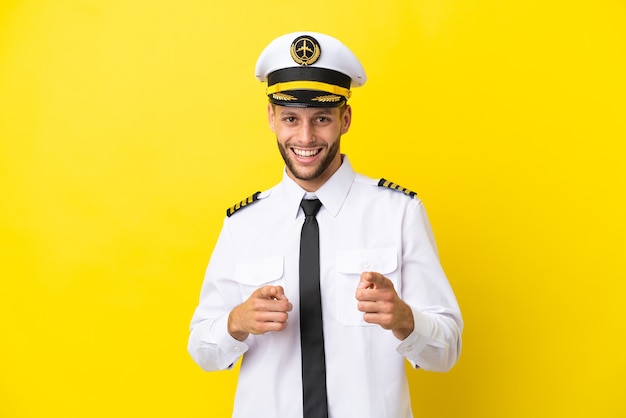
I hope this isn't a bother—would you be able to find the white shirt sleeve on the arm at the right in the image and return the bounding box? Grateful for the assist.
[397,199,463,371]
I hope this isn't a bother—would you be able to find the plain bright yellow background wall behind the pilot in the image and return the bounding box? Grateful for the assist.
[0,0,626,418]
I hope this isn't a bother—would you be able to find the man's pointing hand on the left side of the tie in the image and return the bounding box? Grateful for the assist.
[228,286,293,341]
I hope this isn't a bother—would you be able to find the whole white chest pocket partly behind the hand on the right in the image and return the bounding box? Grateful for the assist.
[335,247,400,326]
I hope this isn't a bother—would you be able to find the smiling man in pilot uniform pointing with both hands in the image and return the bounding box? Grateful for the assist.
[189,32,463,418]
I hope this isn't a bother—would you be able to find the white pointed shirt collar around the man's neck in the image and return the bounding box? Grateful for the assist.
[282,154,356,219]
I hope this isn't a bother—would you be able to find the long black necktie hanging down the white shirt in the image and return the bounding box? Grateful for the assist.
[300,199,328,418]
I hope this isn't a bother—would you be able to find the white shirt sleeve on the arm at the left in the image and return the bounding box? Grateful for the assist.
[187,220,249,371]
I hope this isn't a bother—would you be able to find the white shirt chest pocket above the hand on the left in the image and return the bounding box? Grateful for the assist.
[234,256,285,301]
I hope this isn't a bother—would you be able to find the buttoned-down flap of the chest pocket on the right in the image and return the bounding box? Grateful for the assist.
[337,248,398,274]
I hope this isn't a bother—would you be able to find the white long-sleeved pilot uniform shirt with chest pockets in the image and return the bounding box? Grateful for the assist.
[189,156,463,418]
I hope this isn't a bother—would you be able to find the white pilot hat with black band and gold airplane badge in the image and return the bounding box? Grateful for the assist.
[255,32,367,107]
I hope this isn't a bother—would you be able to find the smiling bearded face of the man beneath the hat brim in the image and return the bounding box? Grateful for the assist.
[268,104,352,191]
